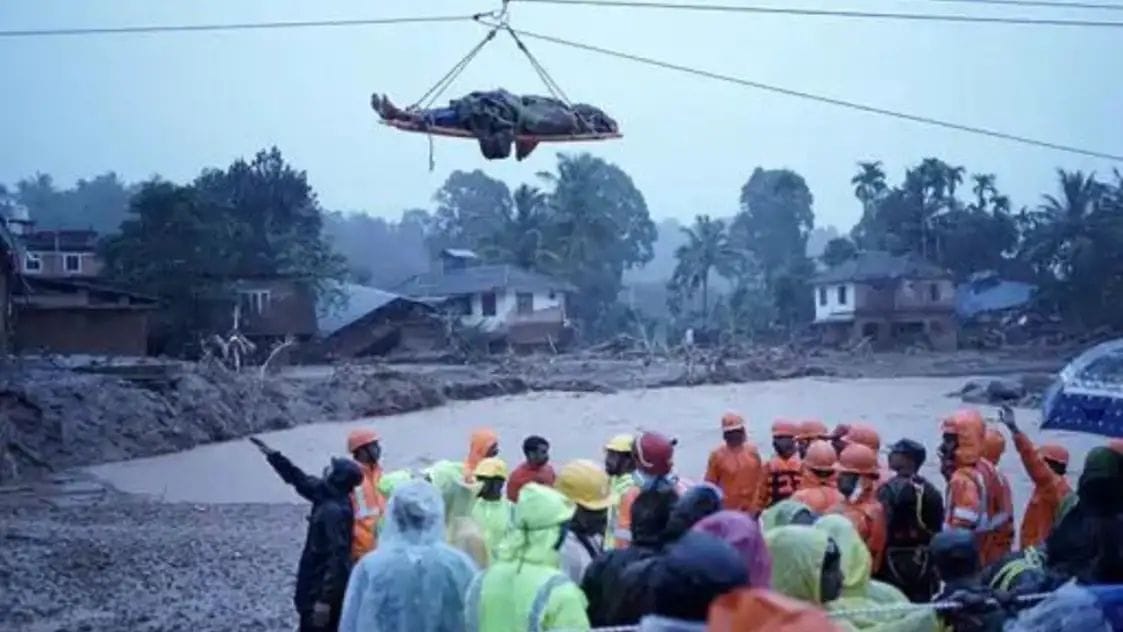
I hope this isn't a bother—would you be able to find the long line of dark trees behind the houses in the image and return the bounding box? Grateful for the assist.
[0,148,1123,350]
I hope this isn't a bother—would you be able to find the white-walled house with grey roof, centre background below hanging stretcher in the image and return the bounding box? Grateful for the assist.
[395,249,575,348]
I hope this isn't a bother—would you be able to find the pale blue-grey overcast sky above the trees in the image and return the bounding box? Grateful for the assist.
[0,0,1123,228]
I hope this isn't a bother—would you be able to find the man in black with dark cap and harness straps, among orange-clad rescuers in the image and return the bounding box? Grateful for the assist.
[877,439,944,603]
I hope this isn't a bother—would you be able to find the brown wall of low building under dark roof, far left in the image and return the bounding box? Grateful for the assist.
[12,306,149,356]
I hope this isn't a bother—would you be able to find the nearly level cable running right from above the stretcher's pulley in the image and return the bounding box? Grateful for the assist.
[512,0,1123,28]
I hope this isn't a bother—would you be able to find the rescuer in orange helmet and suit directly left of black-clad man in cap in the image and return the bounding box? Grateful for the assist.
[833,443,886,570]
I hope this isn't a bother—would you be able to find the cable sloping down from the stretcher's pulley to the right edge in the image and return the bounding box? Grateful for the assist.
[478,20,1123,163]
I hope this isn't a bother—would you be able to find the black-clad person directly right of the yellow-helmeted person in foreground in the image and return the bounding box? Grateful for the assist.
[581,487,678,628]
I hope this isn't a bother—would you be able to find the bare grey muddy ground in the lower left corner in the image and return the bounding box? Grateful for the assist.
[0,484,307,632]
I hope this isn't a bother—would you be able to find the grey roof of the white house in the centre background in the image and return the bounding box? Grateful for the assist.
[394,265,575,297]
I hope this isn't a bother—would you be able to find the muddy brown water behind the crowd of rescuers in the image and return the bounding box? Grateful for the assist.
[90,377,1103,513]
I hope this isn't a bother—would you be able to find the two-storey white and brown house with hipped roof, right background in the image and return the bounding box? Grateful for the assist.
[813,250,959,350]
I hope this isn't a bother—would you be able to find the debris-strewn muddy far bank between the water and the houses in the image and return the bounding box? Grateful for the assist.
[0,348,1069,483]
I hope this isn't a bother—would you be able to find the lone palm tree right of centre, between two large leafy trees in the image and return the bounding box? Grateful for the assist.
[672,216,745,321]
